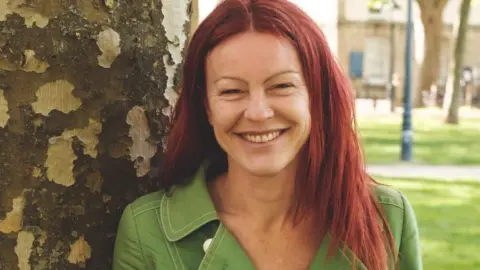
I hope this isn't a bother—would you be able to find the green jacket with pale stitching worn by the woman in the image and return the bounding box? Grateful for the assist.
[113,163,422,270]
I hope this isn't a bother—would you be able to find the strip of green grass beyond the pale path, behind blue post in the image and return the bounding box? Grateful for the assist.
[358,114,480,165]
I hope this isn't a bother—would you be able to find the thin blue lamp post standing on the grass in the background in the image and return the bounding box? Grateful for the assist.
[401,0,413,161]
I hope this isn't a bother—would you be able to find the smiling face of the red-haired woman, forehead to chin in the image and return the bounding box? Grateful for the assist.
[206,31,310,176]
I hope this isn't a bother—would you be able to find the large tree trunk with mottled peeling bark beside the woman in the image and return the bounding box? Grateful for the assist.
[0,0,190,270]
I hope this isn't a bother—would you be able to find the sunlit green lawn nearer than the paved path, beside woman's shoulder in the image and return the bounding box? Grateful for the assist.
[379,178,480,270]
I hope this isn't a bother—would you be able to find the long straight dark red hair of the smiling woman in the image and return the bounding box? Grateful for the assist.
[161,0,396,270]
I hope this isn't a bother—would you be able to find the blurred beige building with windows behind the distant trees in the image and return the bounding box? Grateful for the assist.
[337,0,480,103]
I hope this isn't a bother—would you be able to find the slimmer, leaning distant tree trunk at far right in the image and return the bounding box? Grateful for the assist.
[443,0,472,124]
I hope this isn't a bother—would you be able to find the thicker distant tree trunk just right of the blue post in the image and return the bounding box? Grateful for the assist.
[414,0,448,107]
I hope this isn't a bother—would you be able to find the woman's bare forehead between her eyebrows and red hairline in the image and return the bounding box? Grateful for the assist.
[206,31,300,76]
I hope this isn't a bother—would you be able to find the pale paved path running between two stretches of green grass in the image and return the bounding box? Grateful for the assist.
[367,164,480,181]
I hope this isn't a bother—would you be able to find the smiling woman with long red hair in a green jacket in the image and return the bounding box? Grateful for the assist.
[113,0,422,270]
